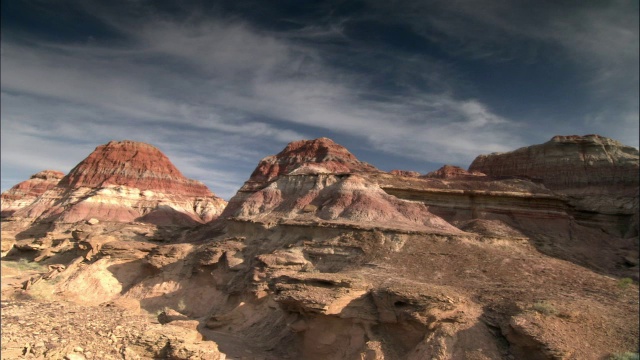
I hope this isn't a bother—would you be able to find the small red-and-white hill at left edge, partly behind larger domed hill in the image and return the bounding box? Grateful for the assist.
[0,170,64,218]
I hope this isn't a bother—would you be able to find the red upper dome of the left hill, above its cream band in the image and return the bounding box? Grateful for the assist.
[60,140,213,196]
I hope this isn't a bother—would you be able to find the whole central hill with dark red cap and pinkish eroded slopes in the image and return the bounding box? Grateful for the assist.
[221,138,459,233]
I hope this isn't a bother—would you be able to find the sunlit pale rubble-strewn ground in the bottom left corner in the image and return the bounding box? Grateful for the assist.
[0,261,225,360]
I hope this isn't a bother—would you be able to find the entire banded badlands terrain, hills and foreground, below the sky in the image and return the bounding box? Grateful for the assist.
[2,135,639,360]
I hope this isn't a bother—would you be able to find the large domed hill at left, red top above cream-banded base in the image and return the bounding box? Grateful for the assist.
[2,141,226,225]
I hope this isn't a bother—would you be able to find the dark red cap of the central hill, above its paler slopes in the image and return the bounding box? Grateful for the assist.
[249,137,379,182]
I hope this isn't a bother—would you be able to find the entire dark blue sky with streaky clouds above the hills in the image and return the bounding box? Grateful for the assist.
[0,0,640,199]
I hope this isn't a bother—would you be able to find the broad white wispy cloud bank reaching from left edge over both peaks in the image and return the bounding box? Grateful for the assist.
[2,4,517,197]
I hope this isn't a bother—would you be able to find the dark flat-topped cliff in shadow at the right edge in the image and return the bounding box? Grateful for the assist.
[469,135,639,237]
